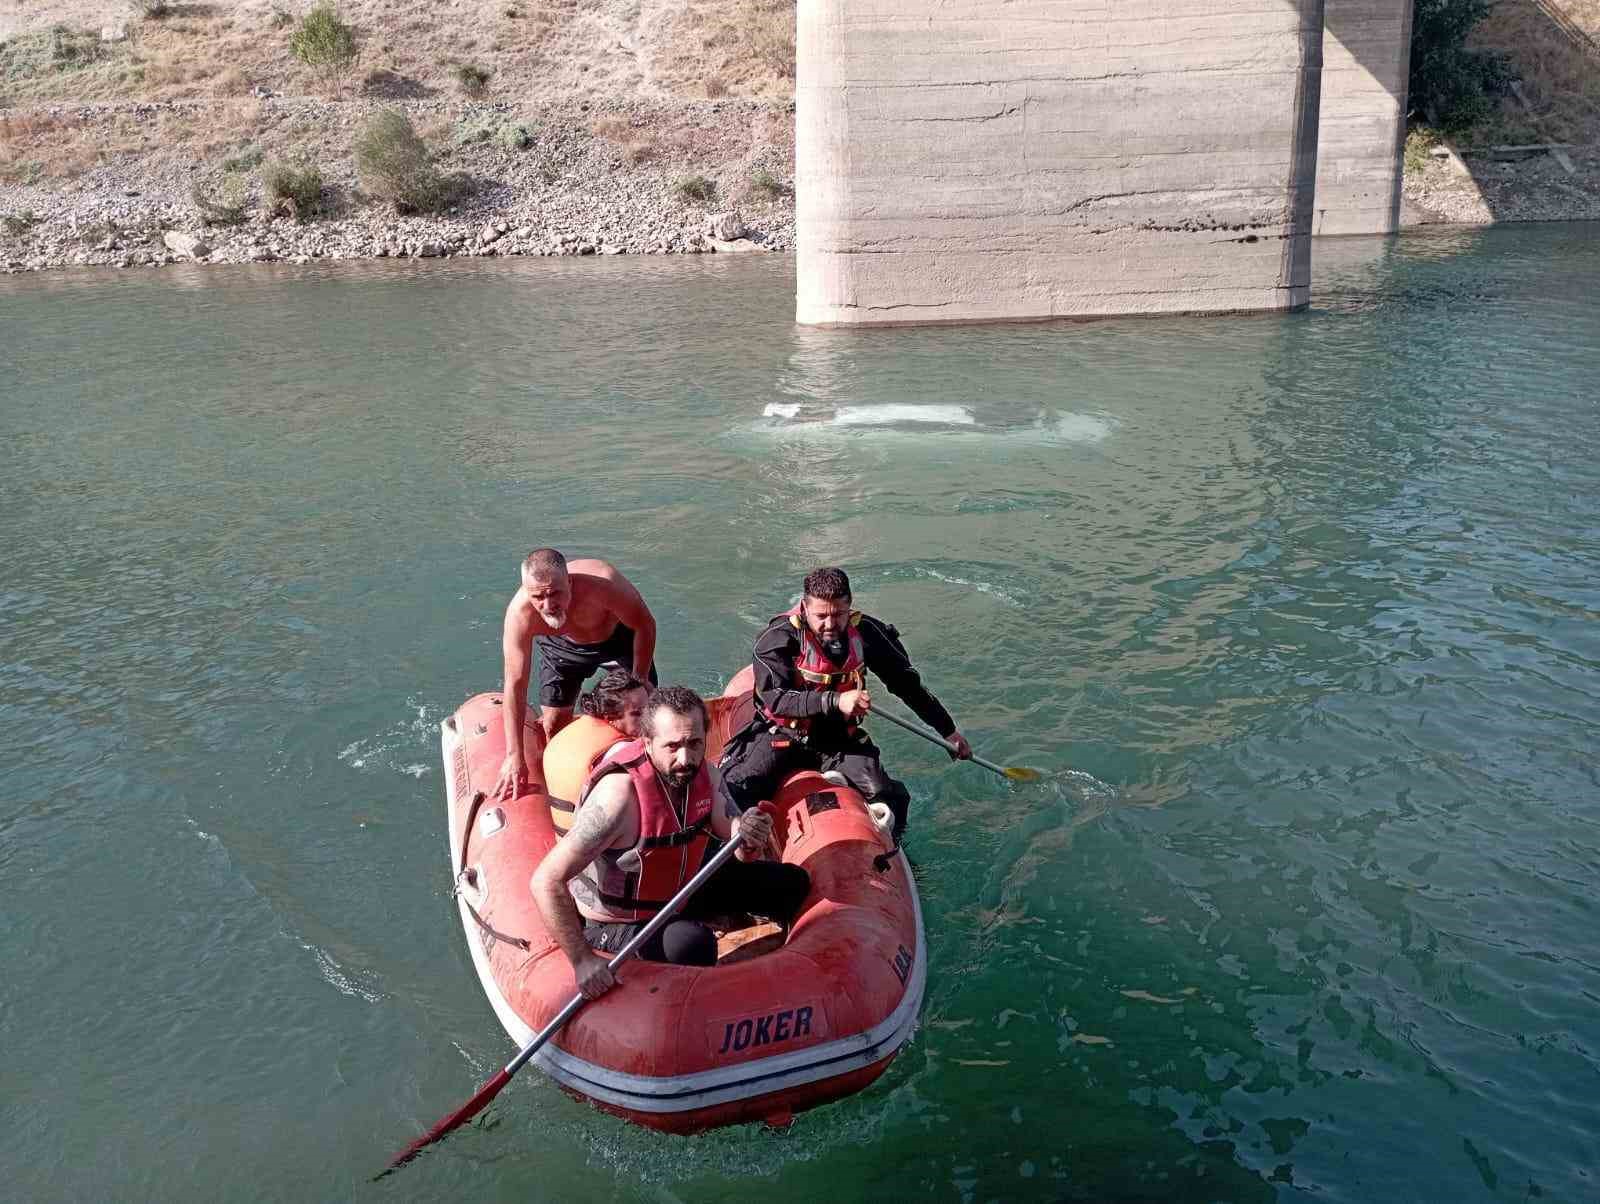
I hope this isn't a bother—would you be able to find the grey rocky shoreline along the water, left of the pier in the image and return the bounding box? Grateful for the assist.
[0,96,794,274]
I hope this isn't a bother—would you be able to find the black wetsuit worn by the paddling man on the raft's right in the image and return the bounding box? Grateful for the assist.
[720,615,955,833]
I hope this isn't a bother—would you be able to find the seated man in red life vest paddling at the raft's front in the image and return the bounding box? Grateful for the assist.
[531,685,811,999]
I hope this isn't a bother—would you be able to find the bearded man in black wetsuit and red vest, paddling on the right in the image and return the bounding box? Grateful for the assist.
[722,568,973,841]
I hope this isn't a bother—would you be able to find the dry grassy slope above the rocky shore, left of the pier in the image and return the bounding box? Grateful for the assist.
[0,0,795,102]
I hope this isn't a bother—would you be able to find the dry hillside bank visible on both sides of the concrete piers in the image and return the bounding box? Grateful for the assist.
[0,0,1600,267]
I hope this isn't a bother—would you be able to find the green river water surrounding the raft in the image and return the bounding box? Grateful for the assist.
[0,226,1600,1201]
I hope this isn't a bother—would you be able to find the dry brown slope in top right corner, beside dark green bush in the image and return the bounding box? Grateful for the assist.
[1462,0,1600,142]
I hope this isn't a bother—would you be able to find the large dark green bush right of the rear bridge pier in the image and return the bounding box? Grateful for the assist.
[1410,0,1517,131]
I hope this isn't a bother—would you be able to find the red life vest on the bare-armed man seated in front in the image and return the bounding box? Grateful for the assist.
[568,740,714,924]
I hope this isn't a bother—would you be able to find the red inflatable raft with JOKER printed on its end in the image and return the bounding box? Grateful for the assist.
[443,676,926,1134]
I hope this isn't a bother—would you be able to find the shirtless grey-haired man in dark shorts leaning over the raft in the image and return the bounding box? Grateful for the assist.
[490,548,656,799]
